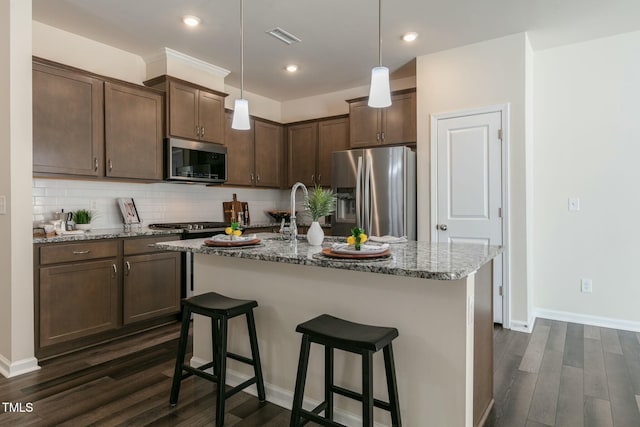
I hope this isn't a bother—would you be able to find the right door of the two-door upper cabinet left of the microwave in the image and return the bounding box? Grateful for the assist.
[105,82,162,180]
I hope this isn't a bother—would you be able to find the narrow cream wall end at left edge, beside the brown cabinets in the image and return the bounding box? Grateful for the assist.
[0,0,37,376]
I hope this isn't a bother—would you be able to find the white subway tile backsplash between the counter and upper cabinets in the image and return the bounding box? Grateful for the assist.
[32,179,290,229]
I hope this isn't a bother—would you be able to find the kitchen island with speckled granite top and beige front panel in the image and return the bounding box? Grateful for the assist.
[157,235,501,426]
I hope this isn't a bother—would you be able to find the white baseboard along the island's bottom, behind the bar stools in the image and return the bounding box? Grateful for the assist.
[189,357,384,427]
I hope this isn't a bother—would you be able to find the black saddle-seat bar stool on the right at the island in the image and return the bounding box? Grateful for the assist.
[290,314,401,427]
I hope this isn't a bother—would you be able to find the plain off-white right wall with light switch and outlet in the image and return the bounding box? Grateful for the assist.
[533,32,640,330]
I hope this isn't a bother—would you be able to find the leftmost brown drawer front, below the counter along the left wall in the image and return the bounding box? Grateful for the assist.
[40,240,118,264]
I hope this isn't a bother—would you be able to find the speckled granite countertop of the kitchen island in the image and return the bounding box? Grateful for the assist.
[156,233,502,280]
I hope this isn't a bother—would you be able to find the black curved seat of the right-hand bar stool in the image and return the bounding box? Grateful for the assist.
[296,314,398,351]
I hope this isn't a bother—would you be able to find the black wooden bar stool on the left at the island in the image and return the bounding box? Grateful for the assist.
[169,292,265,427]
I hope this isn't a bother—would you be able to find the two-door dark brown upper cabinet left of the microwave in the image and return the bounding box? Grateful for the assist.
[33,58,163,181]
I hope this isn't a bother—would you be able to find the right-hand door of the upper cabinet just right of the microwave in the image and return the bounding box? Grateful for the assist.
[254,120,284,188]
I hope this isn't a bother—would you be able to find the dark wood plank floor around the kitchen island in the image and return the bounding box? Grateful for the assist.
[0,319,640,427]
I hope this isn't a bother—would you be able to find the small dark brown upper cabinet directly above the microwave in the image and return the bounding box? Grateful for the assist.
[144,76,227,144]
